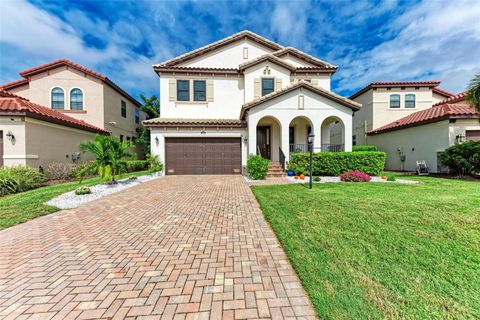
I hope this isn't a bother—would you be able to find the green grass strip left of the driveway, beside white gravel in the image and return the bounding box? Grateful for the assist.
[0,171,148,230]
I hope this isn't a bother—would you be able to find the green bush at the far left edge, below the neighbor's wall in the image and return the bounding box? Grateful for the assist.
[0,166,44,196]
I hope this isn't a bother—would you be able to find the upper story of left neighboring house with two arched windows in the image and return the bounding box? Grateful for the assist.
[0,59,146,154]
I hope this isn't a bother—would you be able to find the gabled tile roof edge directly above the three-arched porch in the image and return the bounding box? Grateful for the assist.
[240,80,362,119]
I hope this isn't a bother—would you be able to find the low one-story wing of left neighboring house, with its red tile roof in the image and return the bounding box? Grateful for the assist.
[0,89,109,167]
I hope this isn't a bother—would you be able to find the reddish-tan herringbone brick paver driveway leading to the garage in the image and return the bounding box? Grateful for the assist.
[0,176,315,319]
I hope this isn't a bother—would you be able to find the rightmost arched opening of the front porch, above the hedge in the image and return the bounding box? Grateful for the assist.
[321,116,345,152]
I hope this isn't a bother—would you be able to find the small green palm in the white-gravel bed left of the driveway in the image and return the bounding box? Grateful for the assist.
[80,135,132,183]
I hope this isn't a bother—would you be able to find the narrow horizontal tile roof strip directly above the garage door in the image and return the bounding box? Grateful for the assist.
[143,118,247,128]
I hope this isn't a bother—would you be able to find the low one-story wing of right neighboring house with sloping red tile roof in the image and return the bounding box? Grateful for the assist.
[368,93,480,172]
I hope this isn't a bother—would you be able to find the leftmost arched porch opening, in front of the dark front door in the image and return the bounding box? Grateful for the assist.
[256,116,282,161]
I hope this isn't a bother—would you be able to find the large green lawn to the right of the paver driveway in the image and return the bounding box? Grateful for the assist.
[252,175,480,319]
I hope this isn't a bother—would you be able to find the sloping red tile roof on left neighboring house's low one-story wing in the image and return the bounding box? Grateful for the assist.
[0,89,110,134]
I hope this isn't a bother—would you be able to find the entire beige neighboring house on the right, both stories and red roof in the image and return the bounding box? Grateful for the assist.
[350,81,480,172]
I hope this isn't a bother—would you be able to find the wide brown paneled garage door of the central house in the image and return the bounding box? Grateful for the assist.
[165,138,242,174]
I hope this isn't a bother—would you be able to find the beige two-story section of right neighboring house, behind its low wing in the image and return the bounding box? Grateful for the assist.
[349,81,453,145]
